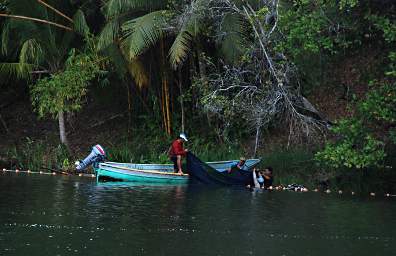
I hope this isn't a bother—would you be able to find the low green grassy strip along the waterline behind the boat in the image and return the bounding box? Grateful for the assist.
[4,134,396,193]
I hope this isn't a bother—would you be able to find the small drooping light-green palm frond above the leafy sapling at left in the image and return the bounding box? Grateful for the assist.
[19,38,43,67]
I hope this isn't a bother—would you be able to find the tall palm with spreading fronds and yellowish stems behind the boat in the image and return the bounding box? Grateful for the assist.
[99,0,245,134]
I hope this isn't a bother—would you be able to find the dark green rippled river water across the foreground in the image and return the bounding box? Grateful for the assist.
[0,172,396,256]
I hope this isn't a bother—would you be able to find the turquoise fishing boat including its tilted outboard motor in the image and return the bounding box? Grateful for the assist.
[76,145,260,183]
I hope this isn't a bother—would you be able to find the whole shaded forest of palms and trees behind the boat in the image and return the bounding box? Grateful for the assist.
[0,0,396,191]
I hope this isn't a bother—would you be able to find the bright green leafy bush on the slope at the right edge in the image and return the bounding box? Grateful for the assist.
[317,13,396,169]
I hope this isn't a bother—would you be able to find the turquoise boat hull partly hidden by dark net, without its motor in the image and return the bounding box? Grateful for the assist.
[95,159,260,184]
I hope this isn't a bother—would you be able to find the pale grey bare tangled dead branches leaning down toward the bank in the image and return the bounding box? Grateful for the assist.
[204,0,326,146]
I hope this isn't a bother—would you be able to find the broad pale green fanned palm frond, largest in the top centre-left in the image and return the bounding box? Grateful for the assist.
[121,11,171,59]
